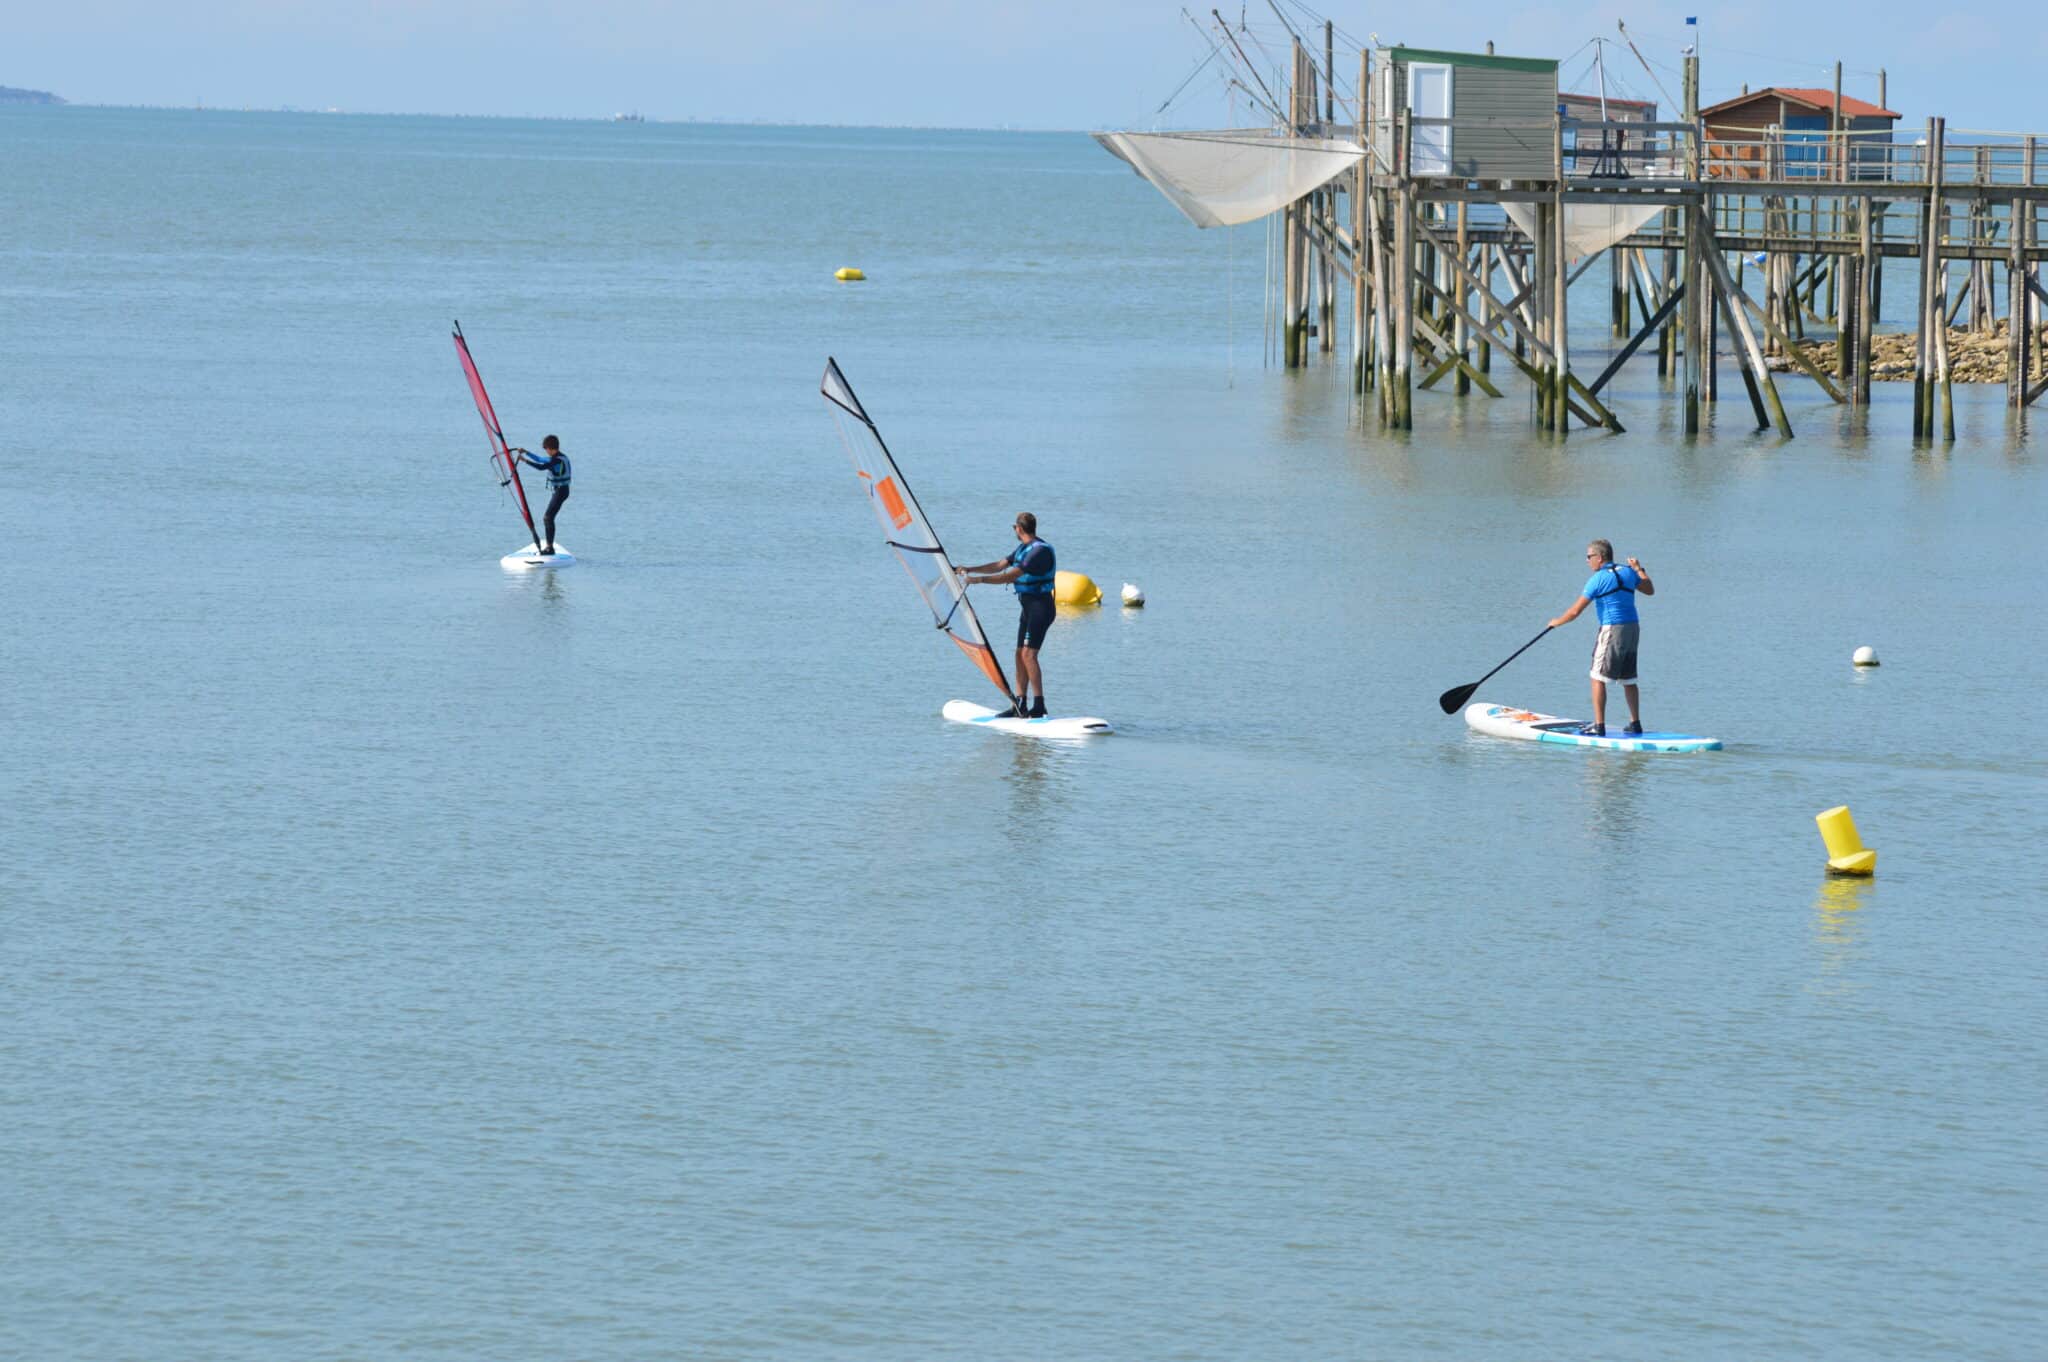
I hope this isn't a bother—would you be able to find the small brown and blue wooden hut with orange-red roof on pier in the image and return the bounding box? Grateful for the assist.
[1700,86,1898,180]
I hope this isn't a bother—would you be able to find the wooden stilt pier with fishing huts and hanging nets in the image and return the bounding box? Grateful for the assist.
[1098,10,2048,440]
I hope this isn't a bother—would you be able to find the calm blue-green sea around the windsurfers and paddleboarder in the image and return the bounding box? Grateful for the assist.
[0,109,2048,1362]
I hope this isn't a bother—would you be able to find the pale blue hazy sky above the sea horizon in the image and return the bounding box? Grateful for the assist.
[0,0,2048,133]
